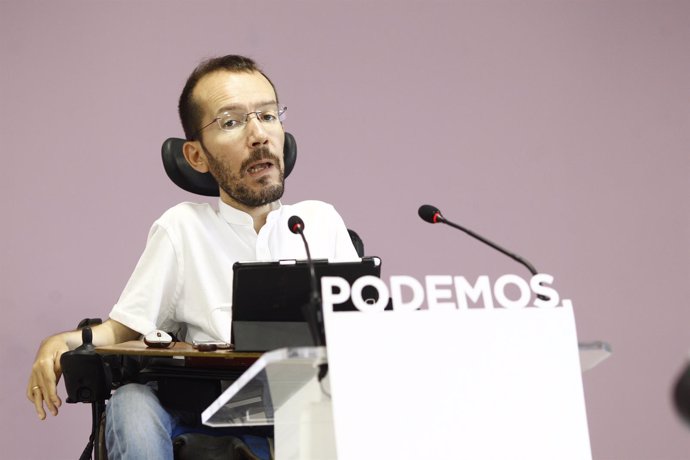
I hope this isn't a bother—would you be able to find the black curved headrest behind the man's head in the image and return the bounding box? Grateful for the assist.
[161,132,297,196]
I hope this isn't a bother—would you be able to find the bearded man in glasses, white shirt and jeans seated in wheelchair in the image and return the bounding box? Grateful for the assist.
[27,55,357,459]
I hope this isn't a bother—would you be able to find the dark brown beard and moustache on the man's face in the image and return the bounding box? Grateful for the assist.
[201,144,285,208]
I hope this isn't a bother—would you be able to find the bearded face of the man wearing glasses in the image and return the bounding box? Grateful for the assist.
[193,71,285,209]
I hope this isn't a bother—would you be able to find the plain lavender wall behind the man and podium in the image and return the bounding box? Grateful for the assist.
[0,0,690,460]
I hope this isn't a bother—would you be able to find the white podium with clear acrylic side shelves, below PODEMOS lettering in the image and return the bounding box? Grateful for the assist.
[202,307,609,460]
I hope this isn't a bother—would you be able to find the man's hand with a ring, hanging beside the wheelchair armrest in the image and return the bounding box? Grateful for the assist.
[26,334,69,420]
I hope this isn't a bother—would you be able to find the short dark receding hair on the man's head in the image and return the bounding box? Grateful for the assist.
[177,54,278,141]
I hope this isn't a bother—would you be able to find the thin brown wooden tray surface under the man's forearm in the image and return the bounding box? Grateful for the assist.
[96,340,262,361]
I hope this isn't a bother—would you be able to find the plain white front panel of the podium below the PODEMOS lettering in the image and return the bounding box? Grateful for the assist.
[325,306,591,460]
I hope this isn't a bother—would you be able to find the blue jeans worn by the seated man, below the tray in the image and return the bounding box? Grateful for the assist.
[105,383,268,460]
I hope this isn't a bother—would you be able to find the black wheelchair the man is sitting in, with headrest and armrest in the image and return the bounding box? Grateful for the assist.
[61,132,364,460]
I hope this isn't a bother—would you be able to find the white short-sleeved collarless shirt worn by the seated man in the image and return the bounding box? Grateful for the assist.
[110,200,358,342]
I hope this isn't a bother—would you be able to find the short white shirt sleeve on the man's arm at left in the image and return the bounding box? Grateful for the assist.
[110,224,182,334]
